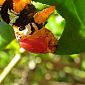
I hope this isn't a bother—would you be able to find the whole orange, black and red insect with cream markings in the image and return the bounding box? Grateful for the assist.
[0,0,57,53]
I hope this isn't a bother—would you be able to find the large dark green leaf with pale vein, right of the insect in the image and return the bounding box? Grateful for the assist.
[35,0,85,54]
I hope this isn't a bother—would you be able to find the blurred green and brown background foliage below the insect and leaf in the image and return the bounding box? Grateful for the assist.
[0,51,85,85]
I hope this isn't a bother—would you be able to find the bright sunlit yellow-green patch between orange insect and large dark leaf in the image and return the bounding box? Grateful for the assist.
[46,13,65,39]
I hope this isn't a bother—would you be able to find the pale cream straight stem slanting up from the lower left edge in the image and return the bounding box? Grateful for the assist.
[0,54,21,84]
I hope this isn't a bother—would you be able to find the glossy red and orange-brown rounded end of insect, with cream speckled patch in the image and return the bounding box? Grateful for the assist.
[15,27,57,53]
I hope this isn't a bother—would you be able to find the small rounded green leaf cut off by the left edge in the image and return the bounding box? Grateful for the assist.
[0,22,14,50]
